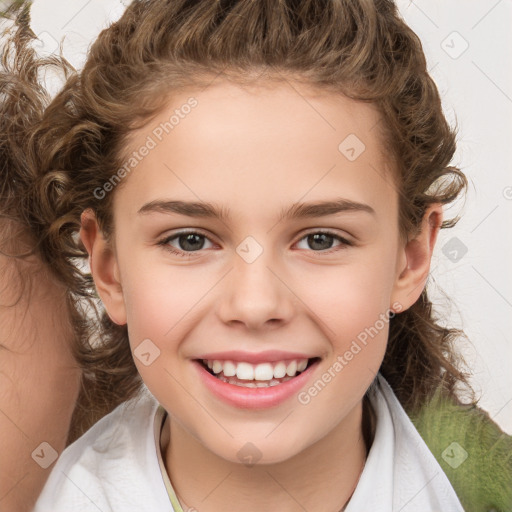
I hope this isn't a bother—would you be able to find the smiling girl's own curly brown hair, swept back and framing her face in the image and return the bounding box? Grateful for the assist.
[5,0,476,438]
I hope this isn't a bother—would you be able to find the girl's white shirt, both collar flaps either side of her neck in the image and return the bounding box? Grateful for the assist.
[34,374,464,512]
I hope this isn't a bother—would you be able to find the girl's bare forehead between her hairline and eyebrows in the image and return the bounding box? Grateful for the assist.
[116,81,394,223]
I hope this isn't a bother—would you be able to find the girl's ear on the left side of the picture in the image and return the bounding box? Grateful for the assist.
[80,209,126,325]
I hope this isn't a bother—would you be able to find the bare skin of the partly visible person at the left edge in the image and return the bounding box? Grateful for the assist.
[0,221,80,512]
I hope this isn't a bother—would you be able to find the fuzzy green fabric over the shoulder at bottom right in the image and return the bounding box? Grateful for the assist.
[410,386,512,512]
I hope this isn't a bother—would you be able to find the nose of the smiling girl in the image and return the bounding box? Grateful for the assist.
[217,245,294,331]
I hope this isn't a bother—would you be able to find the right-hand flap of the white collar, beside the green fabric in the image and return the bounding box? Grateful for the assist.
[345,374,464,512]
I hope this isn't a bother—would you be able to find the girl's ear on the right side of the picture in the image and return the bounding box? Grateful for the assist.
[391,204,443,313]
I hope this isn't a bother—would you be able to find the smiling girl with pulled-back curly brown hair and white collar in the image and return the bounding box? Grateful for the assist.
[10,0,511,512]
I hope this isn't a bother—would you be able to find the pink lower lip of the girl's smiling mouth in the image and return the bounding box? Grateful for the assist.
[193,361,318,409]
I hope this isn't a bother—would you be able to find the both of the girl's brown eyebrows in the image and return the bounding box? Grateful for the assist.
[138,198,376,222]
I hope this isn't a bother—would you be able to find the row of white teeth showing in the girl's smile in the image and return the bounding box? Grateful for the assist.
[203,359,308,387]
